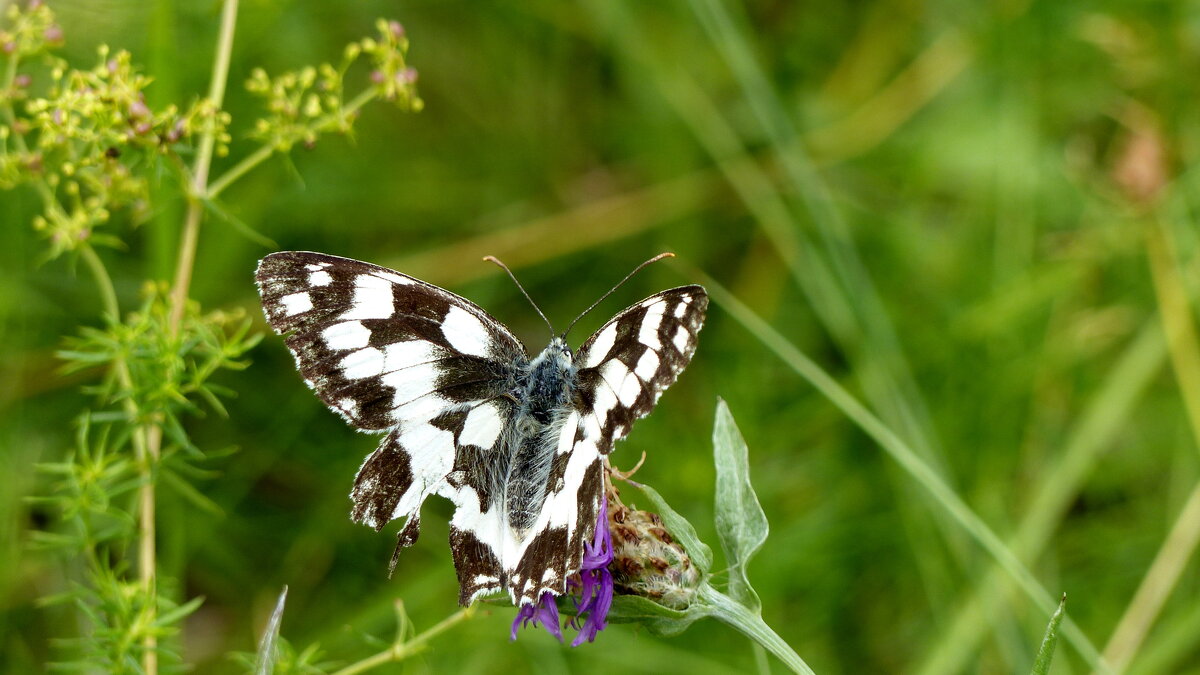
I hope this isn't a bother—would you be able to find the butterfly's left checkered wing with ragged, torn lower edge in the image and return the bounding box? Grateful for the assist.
[256,251,527,542]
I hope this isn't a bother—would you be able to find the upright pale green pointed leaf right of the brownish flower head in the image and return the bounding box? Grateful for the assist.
[713,399,768,611]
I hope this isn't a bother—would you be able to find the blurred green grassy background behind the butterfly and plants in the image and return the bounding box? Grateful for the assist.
[7,0,1200,673]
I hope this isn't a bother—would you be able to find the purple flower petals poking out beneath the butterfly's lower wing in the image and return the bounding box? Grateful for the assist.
[511,495,613,647]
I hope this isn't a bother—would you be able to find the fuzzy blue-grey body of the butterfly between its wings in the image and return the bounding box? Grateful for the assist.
[503,338,575,532]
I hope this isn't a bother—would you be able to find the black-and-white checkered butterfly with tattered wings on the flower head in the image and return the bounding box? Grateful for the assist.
[256,251,708,605]
